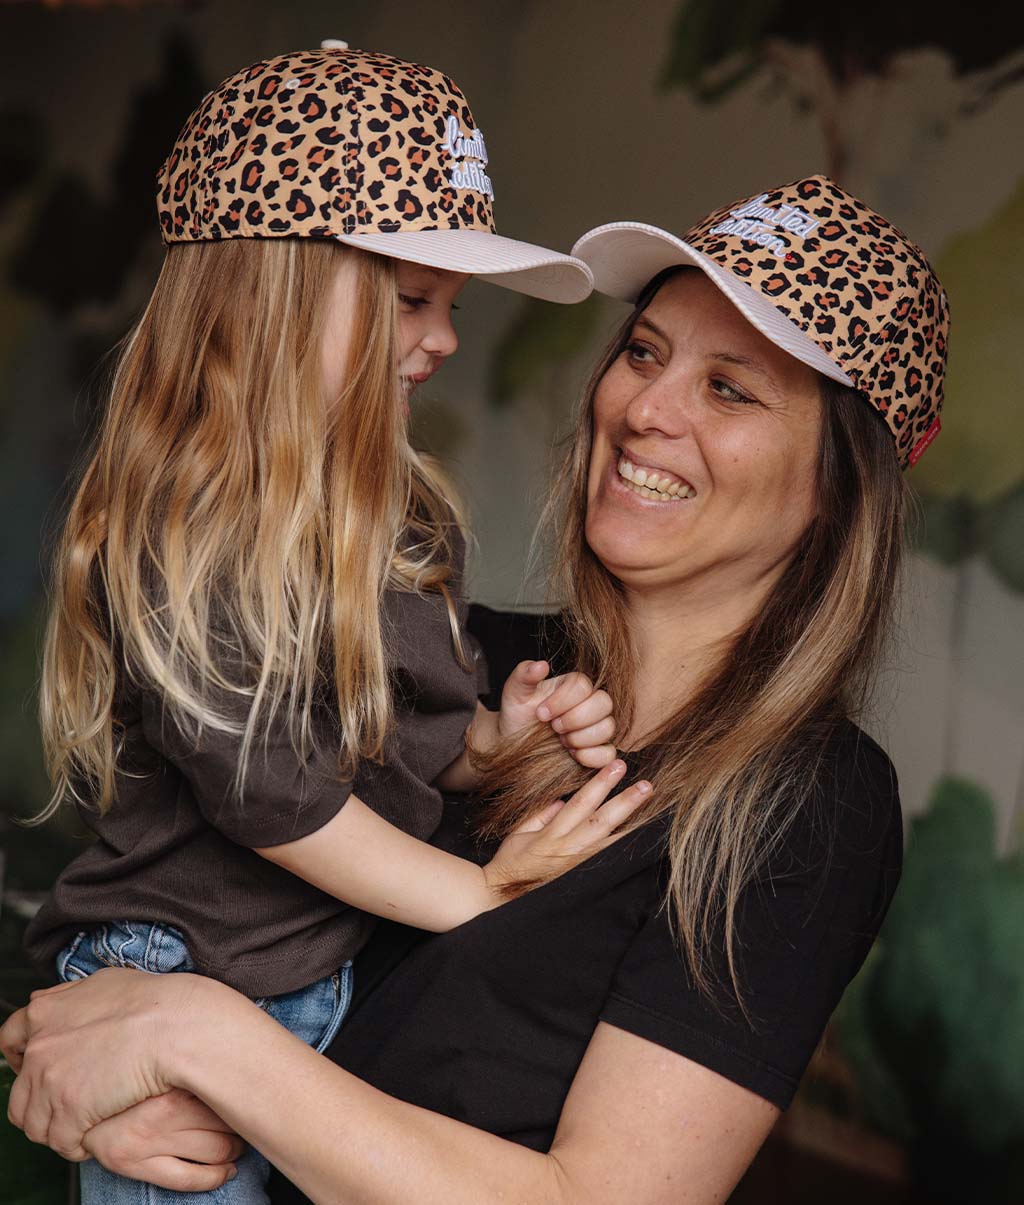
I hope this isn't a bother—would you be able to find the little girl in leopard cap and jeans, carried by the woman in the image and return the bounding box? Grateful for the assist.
[28,48,649,1203]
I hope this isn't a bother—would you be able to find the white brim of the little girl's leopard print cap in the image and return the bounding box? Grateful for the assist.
[335,230,594,304]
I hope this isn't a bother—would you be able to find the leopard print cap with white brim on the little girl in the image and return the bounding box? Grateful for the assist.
[157,41,593,301]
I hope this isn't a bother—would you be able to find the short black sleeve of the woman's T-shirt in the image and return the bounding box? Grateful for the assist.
[601,729,902,1109]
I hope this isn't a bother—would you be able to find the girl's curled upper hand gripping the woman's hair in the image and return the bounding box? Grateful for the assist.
[498,662,616,770]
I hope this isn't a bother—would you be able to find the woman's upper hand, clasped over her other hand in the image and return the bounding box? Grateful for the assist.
[0,969,227,1162]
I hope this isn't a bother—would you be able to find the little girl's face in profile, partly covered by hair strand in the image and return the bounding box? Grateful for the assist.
[323,255,469,404]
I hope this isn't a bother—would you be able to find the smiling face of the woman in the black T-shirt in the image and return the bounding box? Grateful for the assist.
[587,269,822,590]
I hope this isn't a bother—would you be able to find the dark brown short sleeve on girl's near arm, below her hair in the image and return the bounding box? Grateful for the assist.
[141,695,352,848]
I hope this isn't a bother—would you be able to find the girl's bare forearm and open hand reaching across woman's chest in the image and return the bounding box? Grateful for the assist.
[255,760,651,933]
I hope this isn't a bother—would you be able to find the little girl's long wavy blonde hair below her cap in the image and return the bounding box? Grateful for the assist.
[37,239,460,819]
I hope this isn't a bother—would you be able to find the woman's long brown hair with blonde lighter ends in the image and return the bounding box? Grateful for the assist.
[477,281,906,1003]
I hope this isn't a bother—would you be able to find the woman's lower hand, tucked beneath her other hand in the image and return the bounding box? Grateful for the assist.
[83,1088,246,1193]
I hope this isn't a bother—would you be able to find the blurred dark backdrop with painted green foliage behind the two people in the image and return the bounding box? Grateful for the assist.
[0,0,1024,1205]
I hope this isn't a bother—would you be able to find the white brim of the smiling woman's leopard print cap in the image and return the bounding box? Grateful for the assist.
[572,222,854,388]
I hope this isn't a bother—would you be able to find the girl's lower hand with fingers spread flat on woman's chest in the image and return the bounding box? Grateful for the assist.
[483,759,653,901]
